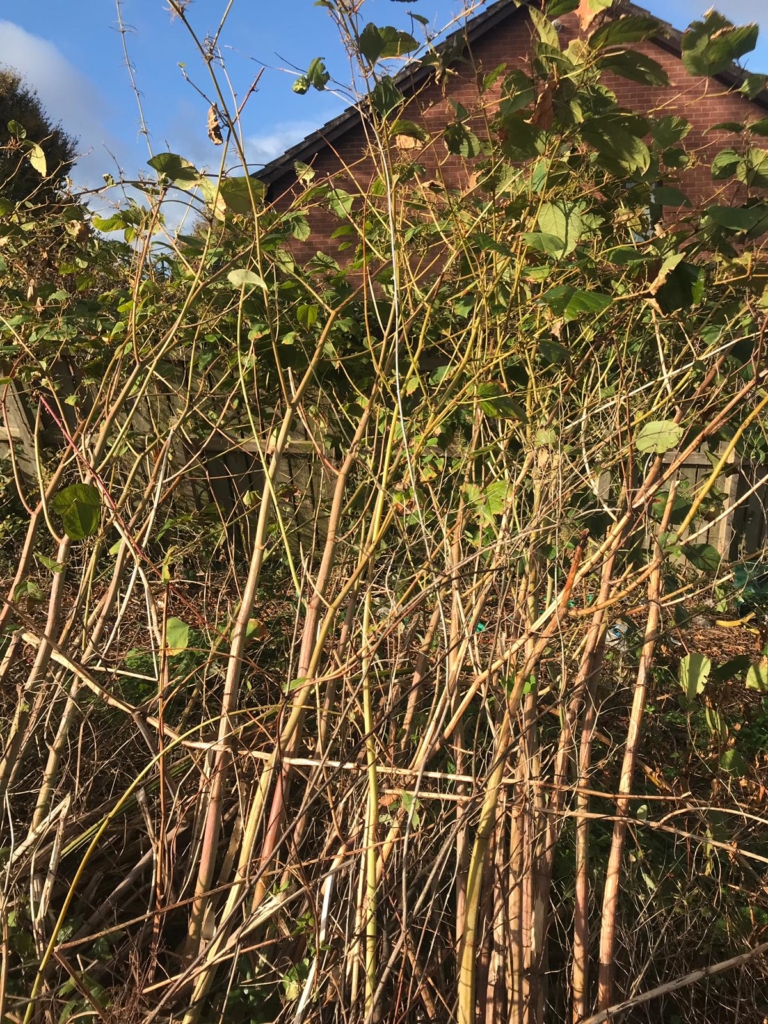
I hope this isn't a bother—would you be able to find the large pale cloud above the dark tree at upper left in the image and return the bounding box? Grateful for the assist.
[0,20,124,186]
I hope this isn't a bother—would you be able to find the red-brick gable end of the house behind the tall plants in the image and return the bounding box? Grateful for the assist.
[255,0,768,254]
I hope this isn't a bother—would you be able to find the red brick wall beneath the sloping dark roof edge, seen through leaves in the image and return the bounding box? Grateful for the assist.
[269,8,765,258]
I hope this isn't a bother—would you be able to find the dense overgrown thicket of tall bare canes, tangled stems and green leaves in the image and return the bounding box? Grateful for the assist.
[0,0,768,1024]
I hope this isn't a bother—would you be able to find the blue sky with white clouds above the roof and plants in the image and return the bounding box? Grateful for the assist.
[0,0,768,191]
